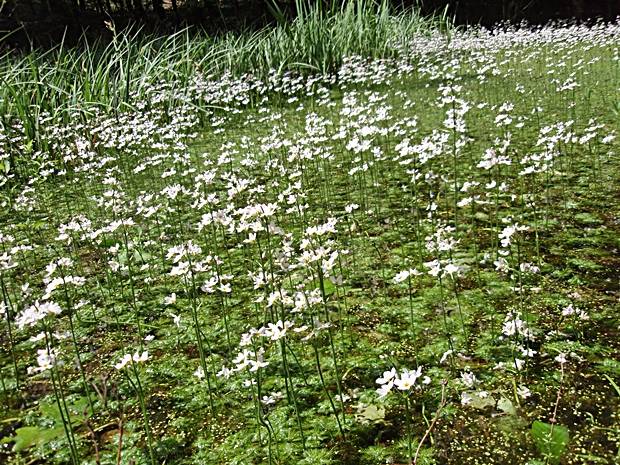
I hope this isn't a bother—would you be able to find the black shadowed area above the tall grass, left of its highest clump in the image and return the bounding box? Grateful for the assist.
[0,0,282,48]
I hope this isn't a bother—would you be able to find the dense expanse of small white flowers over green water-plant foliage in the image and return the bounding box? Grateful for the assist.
[0,19,620,464]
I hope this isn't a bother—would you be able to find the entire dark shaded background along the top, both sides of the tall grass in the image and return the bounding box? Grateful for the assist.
[0,0,620,45]
